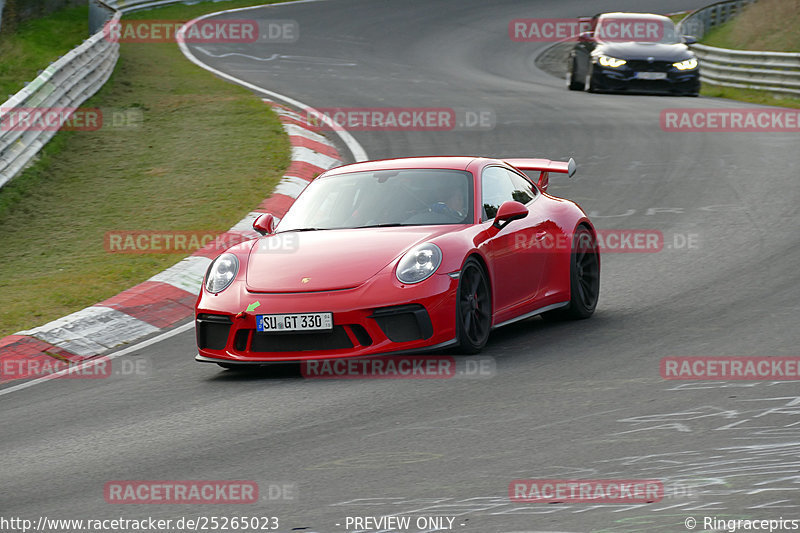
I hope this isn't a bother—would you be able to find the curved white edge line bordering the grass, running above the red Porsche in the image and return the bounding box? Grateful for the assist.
[178,0,368,162]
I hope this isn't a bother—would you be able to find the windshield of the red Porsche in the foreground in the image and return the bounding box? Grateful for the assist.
[277,169,473,231]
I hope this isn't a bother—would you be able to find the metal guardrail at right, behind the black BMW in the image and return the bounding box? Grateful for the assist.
[678,0,800,95]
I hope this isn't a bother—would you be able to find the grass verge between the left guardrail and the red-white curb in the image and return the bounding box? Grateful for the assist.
[0,0,290,336]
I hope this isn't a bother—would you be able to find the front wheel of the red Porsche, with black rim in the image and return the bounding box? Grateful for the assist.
[456,258,492,354]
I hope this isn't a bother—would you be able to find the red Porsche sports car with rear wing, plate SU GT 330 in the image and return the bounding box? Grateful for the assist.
[196,157,600,368]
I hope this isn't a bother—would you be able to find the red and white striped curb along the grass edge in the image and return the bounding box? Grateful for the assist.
[0,103,342,383]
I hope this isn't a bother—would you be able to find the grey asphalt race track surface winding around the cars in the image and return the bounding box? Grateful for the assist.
[0,0,800,533]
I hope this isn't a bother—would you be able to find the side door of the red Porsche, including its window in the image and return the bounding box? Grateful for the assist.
[481,166,549,321]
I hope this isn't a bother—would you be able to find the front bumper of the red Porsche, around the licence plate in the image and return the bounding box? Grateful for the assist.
[195,274,458,364]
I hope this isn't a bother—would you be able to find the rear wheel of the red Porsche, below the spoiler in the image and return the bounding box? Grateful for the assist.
[542,226,600,320]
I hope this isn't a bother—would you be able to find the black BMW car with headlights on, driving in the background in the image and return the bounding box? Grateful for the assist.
[567,13,700,96]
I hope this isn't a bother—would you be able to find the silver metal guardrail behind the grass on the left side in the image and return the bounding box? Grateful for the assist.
[0,0,188,187]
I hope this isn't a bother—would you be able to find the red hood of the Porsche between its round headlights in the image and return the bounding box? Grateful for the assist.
[246,226,460,293]
